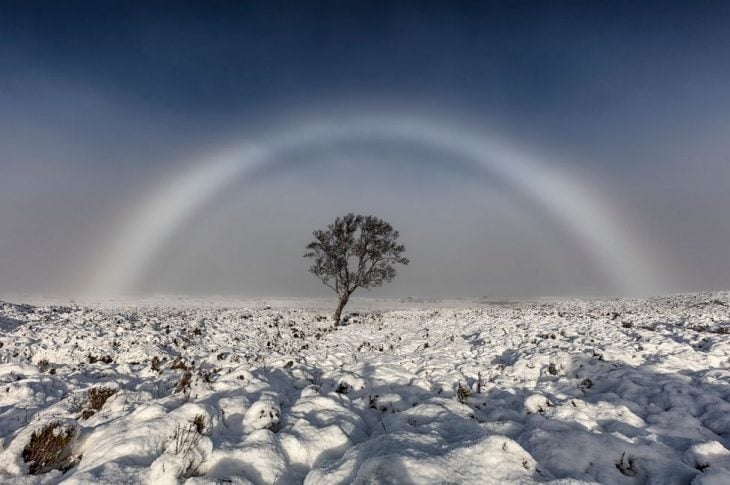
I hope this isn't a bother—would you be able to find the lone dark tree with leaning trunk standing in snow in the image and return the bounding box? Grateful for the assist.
[304,213,408,325]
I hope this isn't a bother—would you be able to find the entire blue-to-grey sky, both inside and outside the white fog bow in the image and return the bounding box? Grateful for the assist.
[0,1,730,298]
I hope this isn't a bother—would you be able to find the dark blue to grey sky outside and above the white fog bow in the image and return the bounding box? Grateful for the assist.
[0,1,730,293]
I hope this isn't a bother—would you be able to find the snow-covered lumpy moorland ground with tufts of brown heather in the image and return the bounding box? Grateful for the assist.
[0,293,730,484]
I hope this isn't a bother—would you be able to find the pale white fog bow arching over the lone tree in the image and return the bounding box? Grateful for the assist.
[85,116,659,295]
